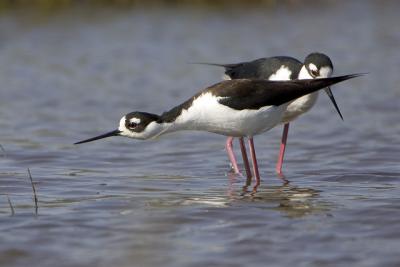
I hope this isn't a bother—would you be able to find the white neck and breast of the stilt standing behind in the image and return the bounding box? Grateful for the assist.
[282,66,318,123]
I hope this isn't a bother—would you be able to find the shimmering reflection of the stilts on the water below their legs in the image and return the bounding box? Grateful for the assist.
[155,173,334,218]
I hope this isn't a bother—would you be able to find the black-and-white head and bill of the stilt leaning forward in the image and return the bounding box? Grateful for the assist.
[75,111,168,144]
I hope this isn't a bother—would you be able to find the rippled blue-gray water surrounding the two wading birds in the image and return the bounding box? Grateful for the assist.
[0,1,400,267]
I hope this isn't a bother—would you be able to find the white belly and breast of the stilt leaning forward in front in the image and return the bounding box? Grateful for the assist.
[168,93,287,137]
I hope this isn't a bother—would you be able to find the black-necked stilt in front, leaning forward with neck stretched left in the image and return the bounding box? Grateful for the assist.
[75,74,360,184]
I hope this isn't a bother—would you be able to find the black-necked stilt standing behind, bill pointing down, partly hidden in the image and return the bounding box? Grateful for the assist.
[195,53,343,175]
